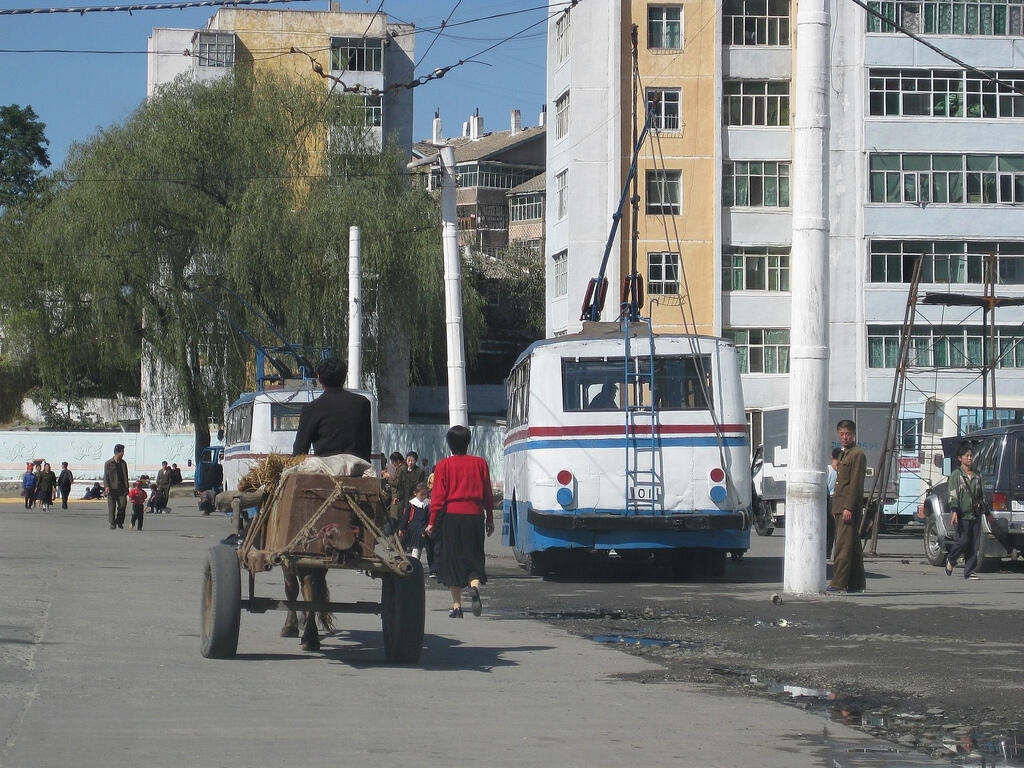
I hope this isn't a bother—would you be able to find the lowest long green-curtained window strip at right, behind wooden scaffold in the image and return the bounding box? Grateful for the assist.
[867,326,1024,369]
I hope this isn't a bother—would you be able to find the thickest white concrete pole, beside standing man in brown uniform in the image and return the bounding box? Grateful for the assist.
[783,0,833,594]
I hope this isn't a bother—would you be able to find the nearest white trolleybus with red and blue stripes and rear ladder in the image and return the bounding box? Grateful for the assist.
[502,324,751,575]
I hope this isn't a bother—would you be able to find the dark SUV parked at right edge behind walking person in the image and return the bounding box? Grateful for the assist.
[925,424,1024,570]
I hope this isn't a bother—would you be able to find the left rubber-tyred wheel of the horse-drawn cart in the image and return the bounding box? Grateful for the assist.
[200,545,242,658]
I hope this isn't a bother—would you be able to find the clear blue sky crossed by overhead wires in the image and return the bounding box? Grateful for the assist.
[0,0,546,167]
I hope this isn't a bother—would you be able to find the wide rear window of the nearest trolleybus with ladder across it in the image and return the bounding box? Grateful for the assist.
[562,354,712,412]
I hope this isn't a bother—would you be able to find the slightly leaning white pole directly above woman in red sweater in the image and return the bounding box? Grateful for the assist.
[438,146,469,427]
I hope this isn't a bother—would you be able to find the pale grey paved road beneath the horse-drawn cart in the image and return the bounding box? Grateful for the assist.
[0,499,946,768]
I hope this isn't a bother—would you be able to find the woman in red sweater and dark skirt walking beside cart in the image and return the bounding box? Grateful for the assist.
[425,425,495,618]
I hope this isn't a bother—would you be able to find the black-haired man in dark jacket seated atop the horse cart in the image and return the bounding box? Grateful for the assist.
[292,357,371,461]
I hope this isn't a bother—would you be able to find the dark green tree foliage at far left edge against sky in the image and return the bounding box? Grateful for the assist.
[0,104,50,208]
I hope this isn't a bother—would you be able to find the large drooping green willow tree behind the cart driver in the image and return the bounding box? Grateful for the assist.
[4,69,479,450]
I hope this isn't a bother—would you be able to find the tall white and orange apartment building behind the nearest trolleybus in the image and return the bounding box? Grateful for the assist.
[545,0,1024,428]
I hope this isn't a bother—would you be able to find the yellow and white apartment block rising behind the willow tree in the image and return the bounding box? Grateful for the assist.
[146,8,415,152]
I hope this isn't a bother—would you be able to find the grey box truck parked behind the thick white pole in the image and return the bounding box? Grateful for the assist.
[754,401,899,536]
